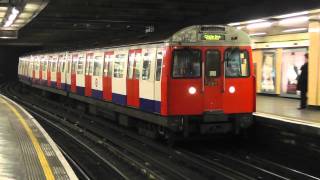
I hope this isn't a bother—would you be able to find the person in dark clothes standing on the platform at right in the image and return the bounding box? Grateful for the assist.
[297,54,309,109]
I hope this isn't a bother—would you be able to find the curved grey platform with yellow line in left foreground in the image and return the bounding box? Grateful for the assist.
[0,95,77,180]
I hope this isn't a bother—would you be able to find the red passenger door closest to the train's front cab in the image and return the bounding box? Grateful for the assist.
[127,49,141,107]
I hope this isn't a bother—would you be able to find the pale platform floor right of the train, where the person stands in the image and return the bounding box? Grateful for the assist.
[256,95,320,127]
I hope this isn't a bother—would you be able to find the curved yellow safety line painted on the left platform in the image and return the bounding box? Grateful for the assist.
[1,98,55,180]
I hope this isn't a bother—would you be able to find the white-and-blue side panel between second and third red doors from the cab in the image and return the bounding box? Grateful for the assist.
[91,51,104,99]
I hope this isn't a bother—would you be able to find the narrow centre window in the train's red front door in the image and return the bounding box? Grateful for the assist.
[205,50,221,77]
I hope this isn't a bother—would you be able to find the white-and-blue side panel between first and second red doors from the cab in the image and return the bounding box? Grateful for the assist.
[111,50,128,105]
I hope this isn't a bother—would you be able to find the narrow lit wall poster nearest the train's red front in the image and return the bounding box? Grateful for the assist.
[261,52,276,94]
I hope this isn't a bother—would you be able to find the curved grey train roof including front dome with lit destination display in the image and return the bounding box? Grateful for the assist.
[20,25,250,56]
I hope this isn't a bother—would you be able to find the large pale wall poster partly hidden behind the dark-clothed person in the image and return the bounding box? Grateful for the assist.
[281,48,308,98]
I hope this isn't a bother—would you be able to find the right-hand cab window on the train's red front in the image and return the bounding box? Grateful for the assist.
[225,48,250,77]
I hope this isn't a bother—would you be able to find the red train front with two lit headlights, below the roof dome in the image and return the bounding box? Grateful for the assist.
[168,46,255,134]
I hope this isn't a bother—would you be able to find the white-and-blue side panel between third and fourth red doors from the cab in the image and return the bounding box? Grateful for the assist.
[76,52,86,96]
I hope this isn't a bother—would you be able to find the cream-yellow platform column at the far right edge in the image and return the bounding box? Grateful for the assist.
[308,21,320,106]
